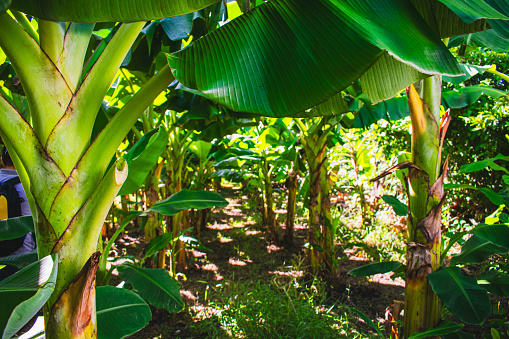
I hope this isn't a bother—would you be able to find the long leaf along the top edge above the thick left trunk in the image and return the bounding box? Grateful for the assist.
[4,0,220,22]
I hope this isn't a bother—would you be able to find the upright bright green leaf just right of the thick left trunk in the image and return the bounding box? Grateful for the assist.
[118,127,168,195]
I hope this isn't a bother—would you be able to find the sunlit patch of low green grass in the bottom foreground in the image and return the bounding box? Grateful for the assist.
[193,279,375,338]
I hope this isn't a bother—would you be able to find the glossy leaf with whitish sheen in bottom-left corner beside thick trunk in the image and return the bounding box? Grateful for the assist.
[0,254,58,339]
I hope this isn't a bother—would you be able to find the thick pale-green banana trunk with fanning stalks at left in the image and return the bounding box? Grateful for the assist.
[0,13,177,339]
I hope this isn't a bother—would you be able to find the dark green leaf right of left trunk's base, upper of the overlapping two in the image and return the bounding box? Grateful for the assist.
[117,263,184,312]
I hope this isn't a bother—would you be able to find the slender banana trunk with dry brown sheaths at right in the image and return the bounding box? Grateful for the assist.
[404,76,450,337]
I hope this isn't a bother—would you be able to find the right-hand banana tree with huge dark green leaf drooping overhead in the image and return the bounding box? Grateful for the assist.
[169,0,507,336]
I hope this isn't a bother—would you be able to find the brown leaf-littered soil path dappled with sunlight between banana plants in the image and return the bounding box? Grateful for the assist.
[111,187,404,339]
